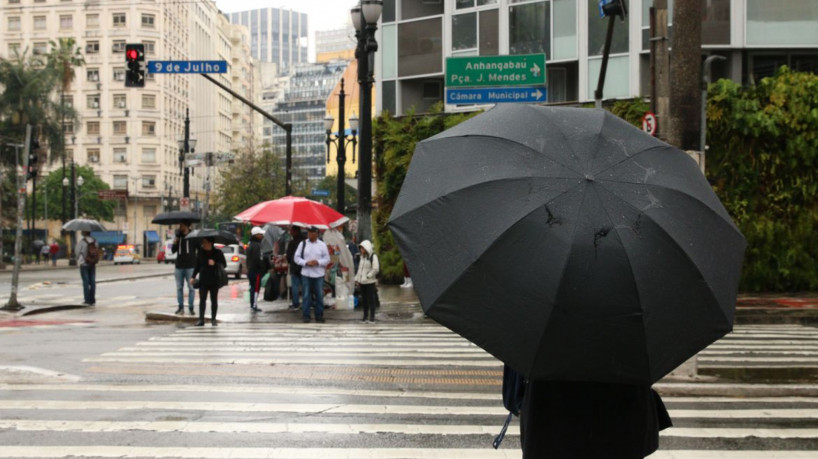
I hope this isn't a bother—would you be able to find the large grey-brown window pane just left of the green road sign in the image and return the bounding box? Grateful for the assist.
[398,17,443,76]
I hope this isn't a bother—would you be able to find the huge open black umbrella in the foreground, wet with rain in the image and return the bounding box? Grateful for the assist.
[389,105,746,383]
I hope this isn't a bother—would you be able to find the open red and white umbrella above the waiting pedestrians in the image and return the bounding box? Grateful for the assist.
[235,196,349,229]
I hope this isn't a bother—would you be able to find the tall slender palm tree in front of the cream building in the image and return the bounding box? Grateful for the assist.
[48,38,85,223]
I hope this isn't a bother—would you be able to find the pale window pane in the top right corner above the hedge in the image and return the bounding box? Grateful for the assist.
[747,0,818,46]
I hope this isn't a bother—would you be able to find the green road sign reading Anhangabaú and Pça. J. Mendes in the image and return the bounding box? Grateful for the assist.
[446,54,545,88]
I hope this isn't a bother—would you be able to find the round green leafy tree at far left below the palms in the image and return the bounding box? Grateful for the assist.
[26,166,116,221]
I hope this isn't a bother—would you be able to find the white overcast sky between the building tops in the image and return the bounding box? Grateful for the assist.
[215,0,358,61]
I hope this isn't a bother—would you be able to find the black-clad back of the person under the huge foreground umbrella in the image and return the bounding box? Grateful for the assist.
[520,381,672,459]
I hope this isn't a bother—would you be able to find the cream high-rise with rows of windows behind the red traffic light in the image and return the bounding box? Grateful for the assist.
[0,0,255,255]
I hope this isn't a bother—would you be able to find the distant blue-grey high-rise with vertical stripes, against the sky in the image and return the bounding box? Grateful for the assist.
[228,8,307,73]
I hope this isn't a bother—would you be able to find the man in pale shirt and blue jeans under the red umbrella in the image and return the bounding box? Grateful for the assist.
[295,226,329,323]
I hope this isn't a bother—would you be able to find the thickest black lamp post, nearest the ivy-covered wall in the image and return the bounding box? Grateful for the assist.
[350,0,383,241]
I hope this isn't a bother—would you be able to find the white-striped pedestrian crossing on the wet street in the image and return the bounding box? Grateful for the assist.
[0,323,818,459]
